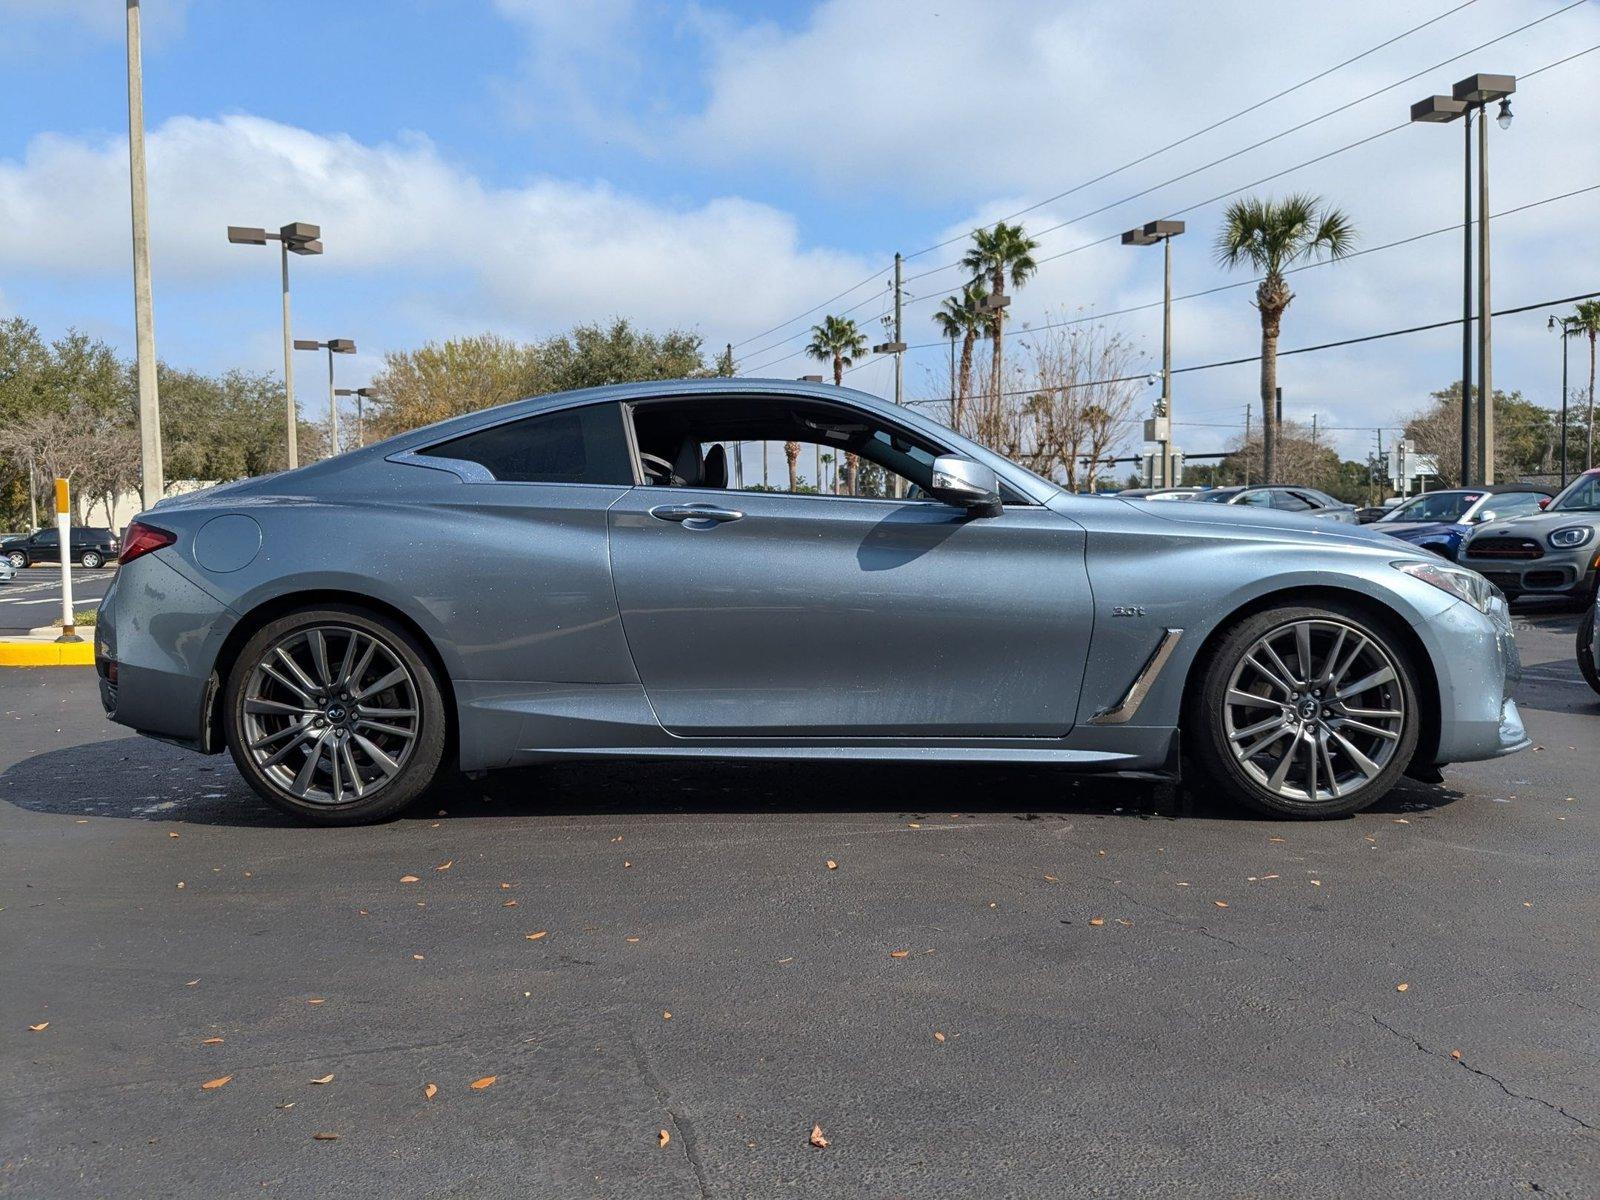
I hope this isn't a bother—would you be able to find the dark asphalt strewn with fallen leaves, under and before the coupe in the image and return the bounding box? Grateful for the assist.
[0,613,1600,1197]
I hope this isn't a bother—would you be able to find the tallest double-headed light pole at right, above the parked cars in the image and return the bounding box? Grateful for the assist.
[1411,75,1517,485]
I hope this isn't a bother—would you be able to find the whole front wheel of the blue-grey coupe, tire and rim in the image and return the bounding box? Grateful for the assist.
[1186,605,1421,818]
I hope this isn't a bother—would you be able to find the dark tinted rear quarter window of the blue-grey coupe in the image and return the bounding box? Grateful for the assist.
[421,405,634,486]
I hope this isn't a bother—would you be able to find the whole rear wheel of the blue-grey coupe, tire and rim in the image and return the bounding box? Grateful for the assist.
[224,606,445,826]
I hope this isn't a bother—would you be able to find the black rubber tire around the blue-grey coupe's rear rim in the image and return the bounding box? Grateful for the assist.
[222,605,446,826]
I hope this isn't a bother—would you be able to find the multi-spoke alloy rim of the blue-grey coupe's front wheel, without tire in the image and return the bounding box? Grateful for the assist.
[1222,619,1410,803]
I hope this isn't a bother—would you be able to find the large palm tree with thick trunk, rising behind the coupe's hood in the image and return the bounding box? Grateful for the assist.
[1216,194,1355,483]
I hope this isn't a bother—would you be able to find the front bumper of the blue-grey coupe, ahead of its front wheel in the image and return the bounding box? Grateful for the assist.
[1414,602,1533,766]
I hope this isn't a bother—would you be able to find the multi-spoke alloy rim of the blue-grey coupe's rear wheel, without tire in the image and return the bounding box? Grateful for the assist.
[242,624,421,805]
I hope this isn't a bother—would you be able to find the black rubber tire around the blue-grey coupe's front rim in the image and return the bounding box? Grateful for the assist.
[1184,600,1422,819]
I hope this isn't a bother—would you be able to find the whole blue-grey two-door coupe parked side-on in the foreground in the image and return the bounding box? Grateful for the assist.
[96,379,1528,824]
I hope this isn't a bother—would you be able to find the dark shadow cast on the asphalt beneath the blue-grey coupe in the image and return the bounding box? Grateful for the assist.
[0,739,1461,827]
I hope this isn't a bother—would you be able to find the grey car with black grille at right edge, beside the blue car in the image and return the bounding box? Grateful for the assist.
[1459,467,1600,608]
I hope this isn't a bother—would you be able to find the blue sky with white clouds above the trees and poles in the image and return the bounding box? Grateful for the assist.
[0,0,1600,454]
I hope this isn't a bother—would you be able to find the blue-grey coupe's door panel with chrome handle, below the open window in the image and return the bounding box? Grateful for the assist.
[608,448,1093,738]
